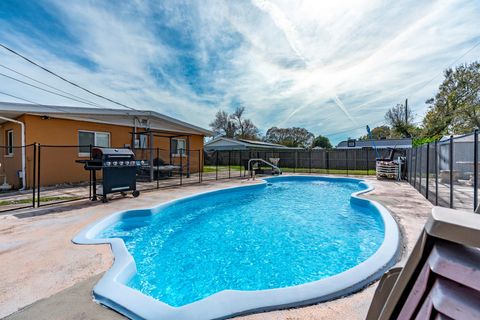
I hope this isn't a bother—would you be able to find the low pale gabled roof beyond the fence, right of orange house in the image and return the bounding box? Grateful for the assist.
[205,137,289,151]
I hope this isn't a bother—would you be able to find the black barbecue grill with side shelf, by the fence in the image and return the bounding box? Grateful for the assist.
[79,147,140,202]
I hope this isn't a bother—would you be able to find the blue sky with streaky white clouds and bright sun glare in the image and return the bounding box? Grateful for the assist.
[0,0,480,143]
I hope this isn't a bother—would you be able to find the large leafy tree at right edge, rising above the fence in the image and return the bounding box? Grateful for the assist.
[422,61,480,137]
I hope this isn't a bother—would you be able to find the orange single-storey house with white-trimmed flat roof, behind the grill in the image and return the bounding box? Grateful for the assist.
[0,102,212,188]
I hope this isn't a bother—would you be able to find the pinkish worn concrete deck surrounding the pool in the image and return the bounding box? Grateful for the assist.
[0,177,432,320]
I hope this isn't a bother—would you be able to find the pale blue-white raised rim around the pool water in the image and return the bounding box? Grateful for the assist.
[72,175,400,320]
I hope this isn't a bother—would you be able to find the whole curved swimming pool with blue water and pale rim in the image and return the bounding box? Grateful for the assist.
[74,176,398,319]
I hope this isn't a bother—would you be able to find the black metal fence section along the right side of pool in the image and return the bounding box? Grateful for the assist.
[407,130,480,210]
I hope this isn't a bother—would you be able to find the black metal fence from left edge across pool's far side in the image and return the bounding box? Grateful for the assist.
[0,144,384,213]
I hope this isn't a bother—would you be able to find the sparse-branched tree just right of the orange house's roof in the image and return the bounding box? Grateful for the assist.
[210,107,259,140]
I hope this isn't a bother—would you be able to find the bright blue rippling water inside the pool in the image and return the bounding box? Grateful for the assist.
[98,177,384,306]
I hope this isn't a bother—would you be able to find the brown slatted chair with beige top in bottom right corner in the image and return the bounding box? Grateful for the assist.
[367,207,480,320]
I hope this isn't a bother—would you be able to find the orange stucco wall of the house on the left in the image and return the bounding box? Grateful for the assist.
[0,115,204,187]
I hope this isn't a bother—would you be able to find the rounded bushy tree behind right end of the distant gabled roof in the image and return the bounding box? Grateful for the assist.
[264,127,314,148]
